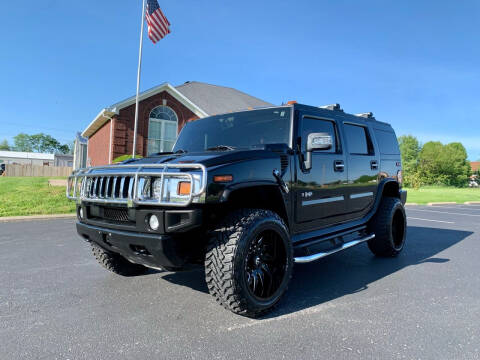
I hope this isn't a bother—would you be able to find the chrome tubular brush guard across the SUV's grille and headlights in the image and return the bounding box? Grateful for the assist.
[66,164,207,207]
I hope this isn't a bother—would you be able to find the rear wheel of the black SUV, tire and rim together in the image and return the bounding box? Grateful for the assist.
[368,197,407,257]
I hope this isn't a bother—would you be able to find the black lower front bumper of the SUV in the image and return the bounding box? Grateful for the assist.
[77,222,185,268]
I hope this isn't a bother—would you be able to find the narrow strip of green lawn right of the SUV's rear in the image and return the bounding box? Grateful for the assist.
[406,186,480,204]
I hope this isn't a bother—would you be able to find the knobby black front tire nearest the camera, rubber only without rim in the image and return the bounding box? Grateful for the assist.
[205,209,293,317]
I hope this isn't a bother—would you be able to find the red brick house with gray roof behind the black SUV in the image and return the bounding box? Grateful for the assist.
[82,81,272,166]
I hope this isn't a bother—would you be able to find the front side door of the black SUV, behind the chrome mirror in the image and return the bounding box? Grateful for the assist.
[295,115,347,231]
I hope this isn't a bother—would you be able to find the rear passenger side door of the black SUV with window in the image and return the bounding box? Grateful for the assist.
[343,122,380,218]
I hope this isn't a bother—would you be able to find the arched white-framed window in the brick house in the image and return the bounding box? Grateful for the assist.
[147,105,178,155]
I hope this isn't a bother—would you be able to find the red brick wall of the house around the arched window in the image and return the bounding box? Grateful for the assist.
[88,91,198,166]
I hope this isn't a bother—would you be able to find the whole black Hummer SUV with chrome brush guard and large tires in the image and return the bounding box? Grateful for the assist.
[67,104,406,316]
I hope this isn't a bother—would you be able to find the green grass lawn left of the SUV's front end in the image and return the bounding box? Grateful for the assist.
[0,176,75,217]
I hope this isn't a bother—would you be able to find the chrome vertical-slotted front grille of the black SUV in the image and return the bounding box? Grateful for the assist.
[84,176,135,199]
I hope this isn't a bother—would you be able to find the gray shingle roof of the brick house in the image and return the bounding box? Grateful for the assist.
[175,81,273,115]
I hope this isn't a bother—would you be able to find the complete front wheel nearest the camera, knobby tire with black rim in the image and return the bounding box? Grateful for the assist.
[205,209,293,317]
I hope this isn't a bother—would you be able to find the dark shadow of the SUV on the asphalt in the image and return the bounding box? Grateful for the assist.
[158,226,473,318]
